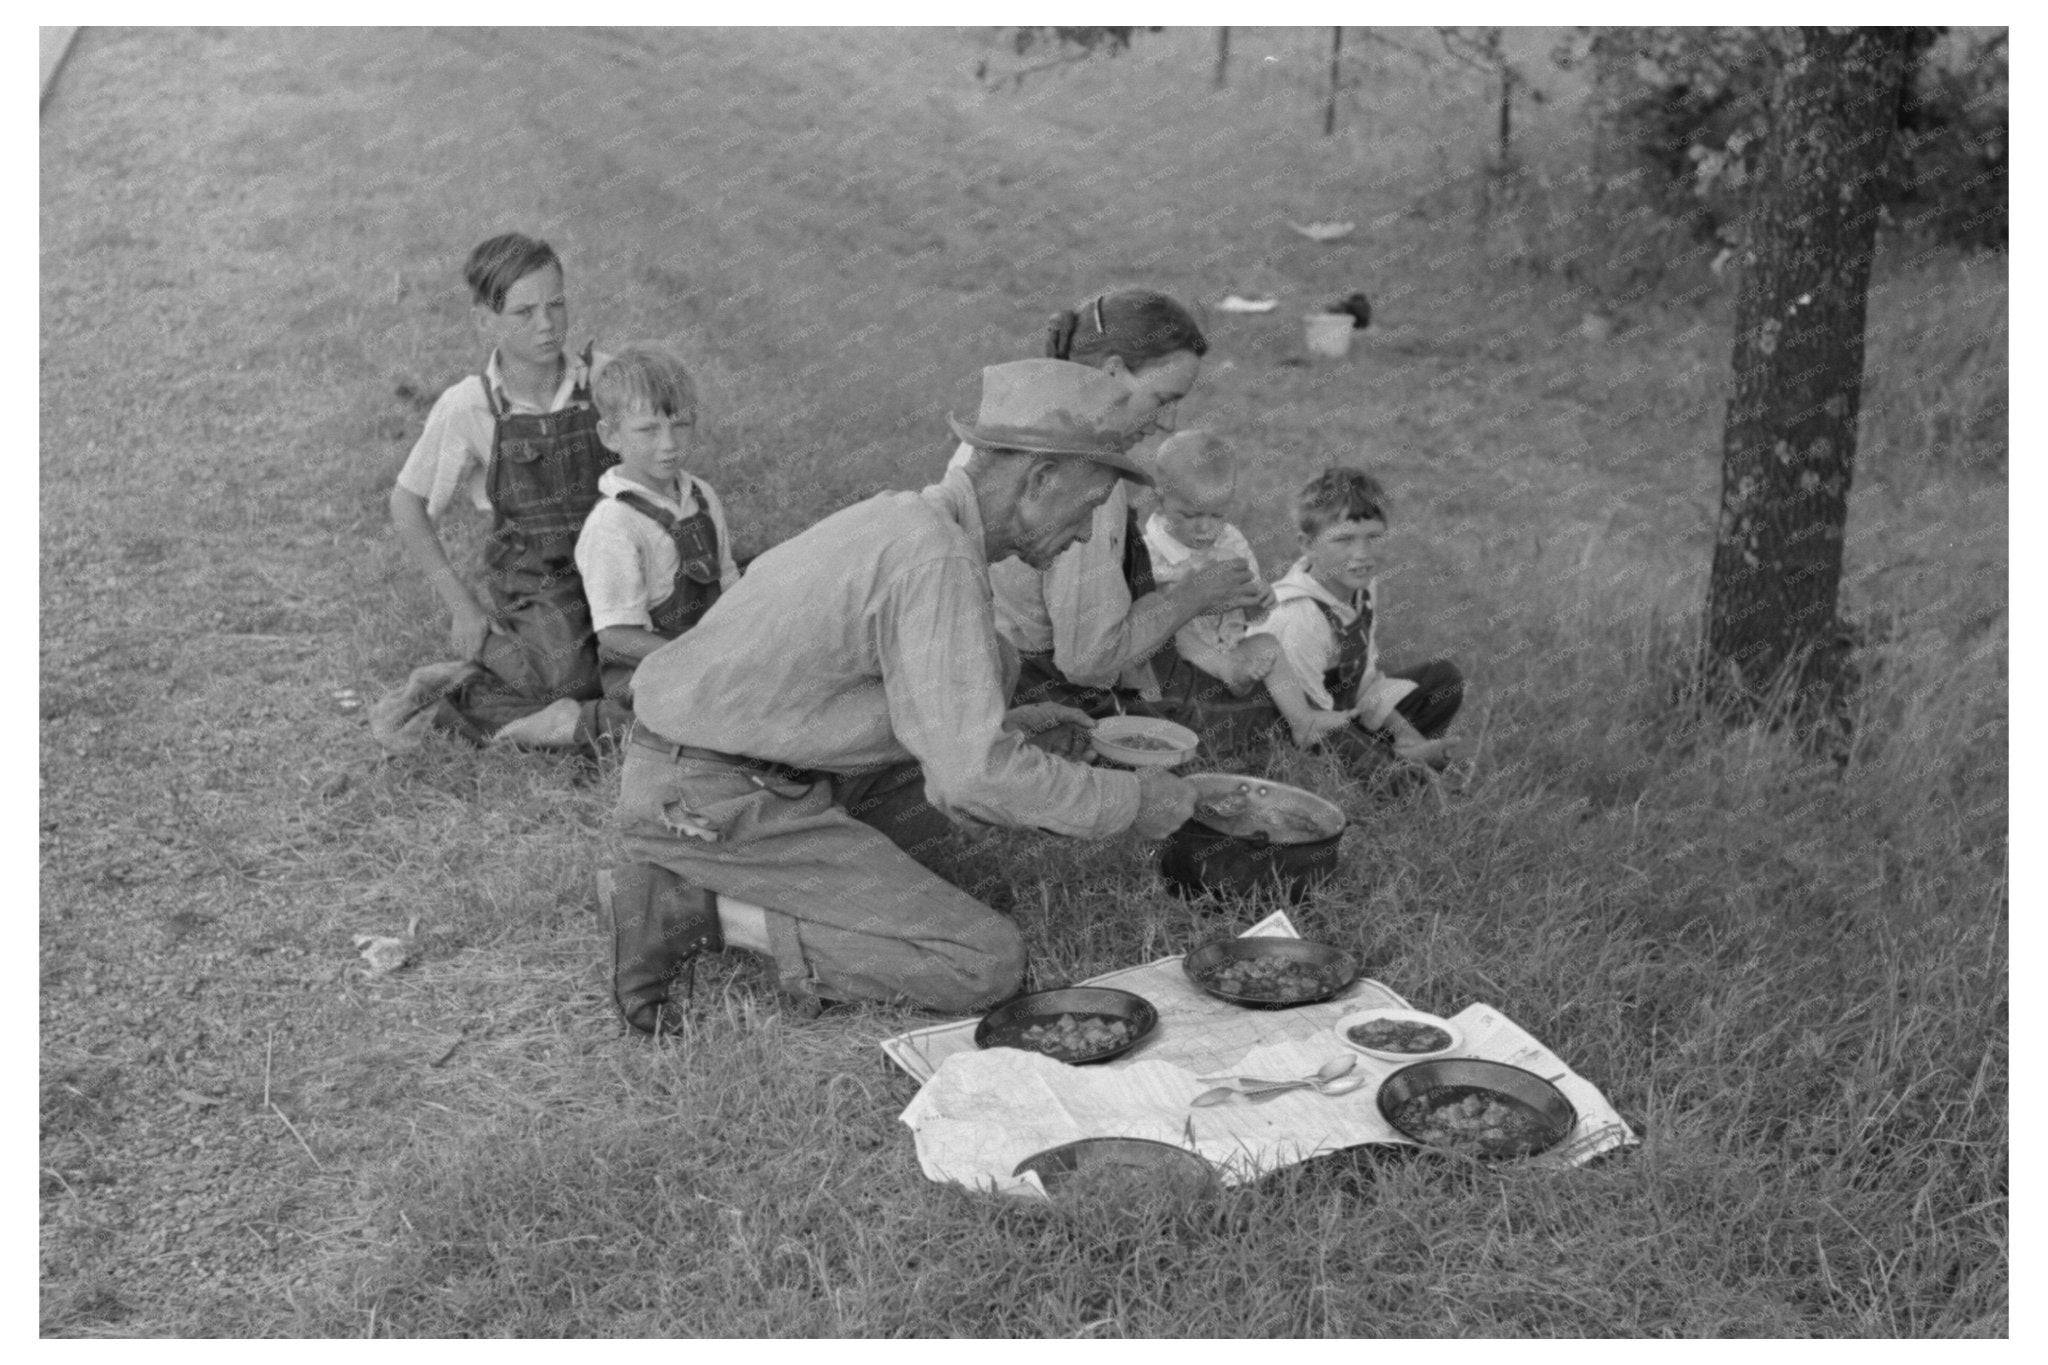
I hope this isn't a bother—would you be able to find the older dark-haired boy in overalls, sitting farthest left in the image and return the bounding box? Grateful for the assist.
[373,233,618,747]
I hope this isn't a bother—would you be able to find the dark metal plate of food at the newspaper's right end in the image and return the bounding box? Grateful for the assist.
[1378,1058,1579,1160]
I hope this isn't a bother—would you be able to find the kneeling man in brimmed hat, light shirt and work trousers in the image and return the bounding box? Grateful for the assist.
[610,360,1194,1033]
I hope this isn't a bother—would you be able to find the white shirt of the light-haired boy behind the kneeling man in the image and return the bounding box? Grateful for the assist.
[575,465,739,630]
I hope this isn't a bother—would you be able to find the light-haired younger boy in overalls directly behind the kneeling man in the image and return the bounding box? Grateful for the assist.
[575,344,739,729]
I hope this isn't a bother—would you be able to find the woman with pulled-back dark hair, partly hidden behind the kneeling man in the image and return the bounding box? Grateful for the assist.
[952,289,1272,716]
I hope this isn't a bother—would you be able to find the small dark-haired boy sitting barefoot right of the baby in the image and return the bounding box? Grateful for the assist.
[1251,465,1464,774]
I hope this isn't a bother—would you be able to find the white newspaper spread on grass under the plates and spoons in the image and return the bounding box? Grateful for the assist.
[883,911,1636,1195]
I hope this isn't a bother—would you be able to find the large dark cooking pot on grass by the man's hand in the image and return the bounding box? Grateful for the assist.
[1159,774,1348,905]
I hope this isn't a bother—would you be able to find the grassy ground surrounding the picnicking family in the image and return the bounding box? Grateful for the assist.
[39,29,2007,1336]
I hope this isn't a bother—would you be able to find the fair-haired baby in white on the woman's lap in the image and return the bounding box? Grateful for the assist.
[1145,432,1309,739]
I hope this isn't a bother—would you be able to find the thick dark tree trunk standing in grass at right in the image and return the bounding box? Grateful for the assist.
[1706,29,1907,704]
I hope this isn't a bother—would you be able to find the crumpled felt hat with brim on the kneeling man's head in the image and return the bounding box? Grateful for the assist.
[946,360,1153,483]
